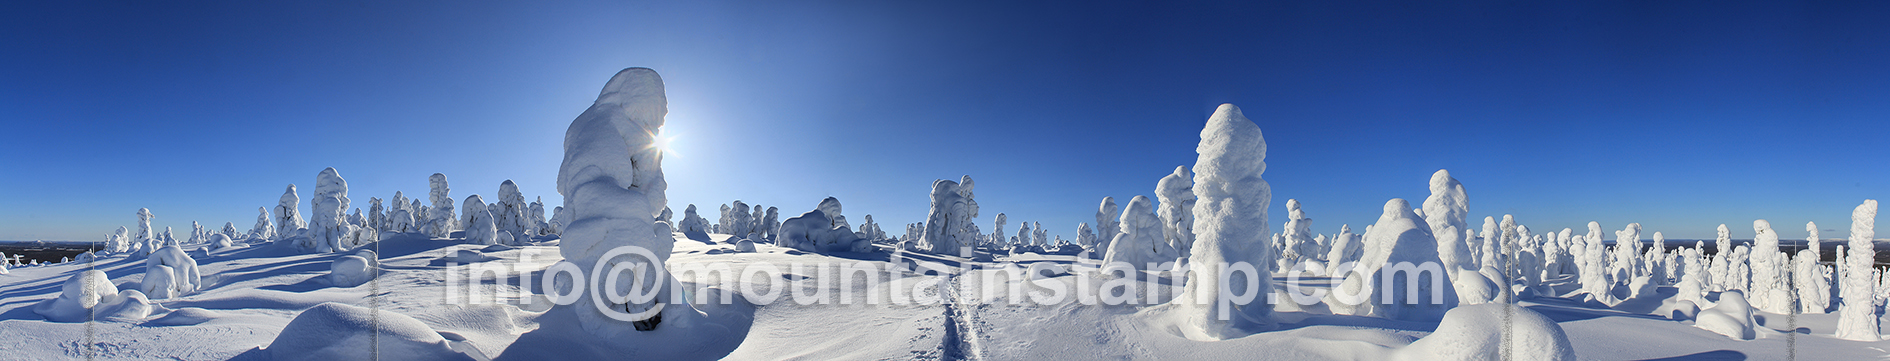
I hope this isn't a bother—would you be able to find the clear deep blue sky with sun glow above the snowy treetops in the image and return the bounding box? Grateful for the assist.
[0,2,1890,240]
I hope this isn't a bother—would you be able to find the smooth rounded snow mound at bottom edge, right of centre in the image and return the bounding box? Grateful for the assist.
[1397,304,1574,361]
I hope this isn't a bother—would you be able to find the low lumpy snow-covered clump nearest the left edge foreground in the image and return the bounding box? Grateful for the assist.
[32,270,151,323]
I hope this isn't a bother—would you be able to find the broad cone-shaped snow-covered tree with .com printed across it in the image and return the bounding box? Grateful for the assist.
[1327,198,1457,321]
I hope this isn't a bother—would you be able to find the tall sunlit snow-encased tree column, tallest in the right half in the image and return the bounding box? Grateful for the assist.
[1164,104,1274,340]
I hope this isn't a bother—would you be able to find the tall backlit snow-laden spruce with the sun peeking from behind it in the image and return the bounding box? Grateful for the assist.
[540,68,739,359]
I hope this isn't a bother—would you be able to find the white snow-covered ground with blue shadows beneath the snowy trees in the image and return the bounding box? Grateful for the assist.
[0,232,1890,359]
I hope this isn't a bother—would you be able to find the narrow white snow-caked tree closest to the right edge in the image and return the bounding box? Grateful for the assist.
[1837,198,1882,340]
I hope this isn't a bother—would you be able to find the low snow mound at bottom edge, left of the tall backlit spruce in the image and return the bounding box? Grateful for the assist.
[265,302,484,361]
